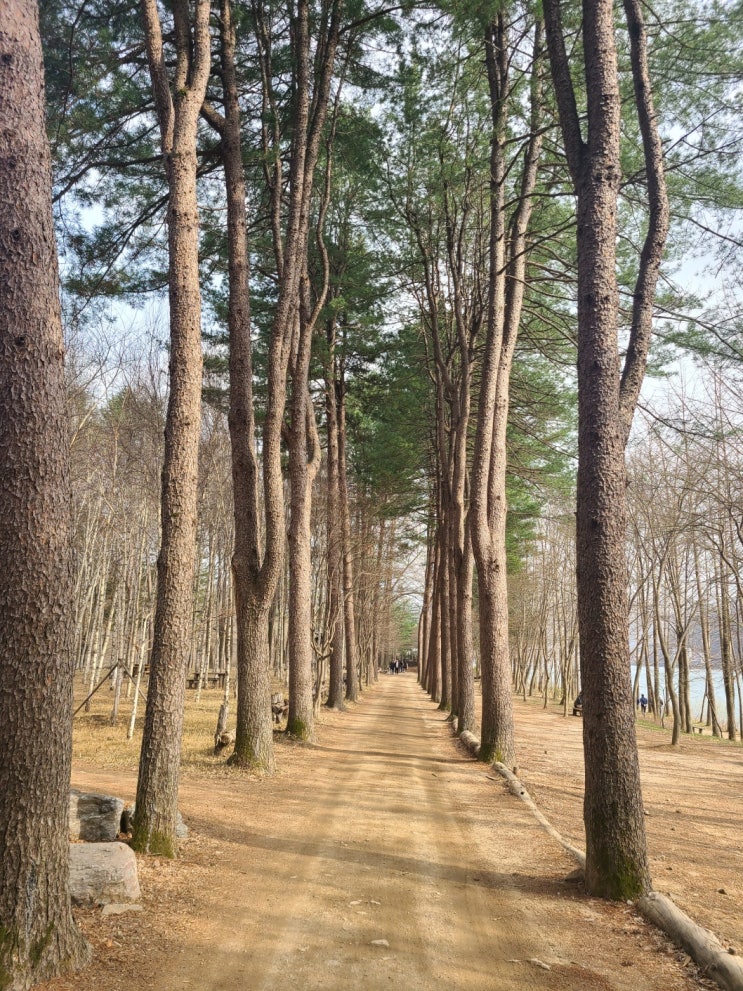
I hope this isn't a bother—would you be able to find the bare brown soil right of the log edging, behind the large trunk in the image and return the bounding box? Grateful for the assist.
[515,700,743,954]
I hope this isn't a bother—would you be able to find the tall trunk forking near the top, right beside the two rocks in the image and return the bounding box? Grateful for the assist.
[132,0,210,857]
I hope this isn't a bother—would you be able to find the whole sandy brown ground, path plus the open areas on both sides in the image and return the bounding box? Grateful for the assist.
[41,673,743,991]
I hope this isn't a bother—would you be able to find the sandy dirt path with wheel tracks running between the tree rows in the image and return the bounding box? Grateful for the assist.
[47,674,707,991]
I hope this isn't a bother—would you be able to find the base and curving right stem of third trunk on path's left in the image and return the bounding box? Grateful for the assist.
[224,0,341,760]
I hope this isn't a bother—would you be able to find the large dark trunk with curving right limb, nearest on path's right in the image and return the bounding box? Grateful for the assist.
[544,0,668,899]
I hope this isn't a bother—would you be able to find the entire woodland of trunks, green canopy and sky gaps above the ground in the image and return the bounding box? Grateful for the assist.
[0,0,743,991]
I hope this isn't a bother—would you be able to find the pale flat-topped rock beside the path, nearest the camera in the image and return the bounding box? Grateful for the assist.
[70,843,140,905]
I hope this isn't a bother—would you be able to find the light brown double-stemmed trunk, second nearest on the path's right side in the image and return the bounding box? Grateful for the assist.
[470,12,541,766]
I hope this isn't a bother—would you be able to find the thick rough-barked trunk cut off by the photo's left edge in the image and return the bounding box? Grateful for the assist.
[0,0,87,991]
